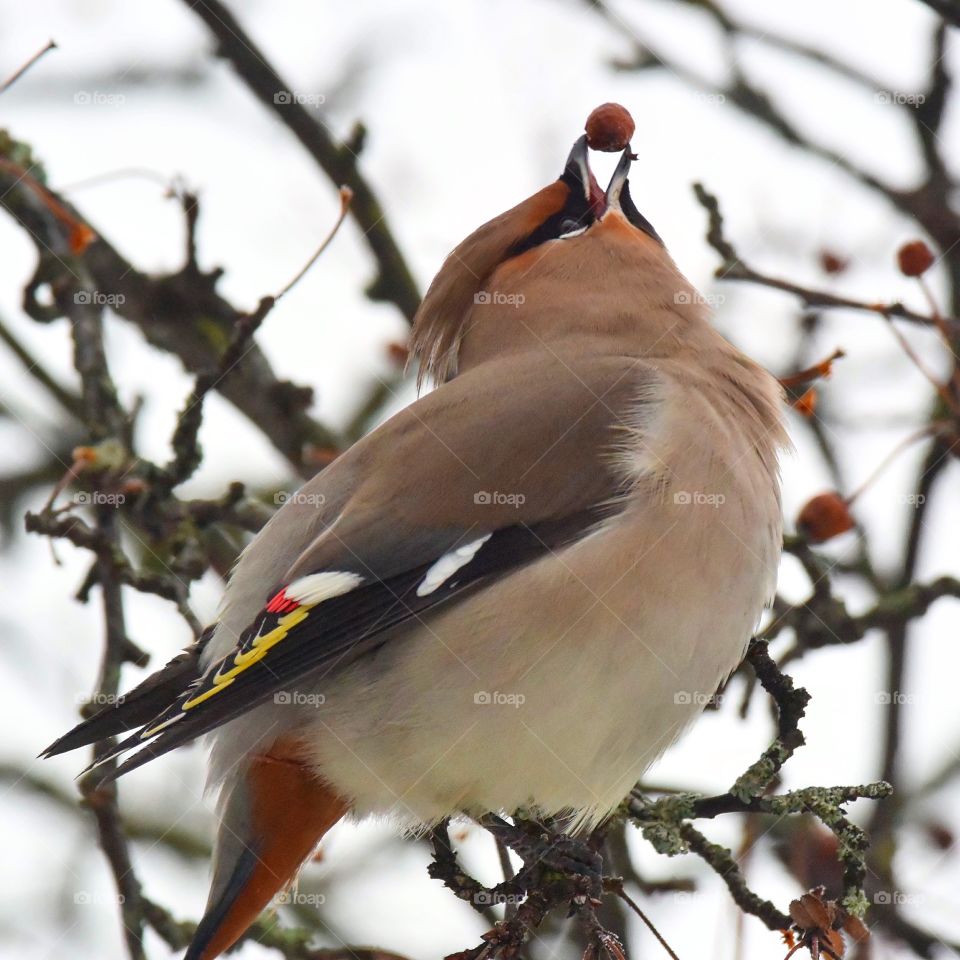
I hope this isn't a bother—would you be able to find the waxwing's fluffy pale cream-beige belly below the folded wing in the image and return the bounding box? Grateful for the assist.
[307,506,767,822]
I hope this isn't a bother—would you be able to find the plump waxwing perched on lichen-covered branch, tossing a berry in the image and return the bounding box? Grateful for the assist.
[45,107,788,960]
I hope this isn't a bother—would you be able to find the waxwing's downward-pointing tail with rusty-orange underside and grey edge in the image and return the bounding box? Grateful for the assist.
[184,740,349,960]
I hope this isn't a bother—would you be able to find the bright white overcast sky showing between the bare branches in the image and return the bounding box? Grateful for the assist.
[0,0,960,960]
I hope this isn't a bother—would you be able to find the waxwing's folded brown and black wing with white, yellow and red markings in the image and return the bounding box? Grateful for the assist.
[47,356,651,776]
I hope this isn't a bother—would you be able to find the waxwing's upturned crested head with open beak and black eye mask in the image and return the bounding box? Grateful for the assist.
[411,126,705,382]
